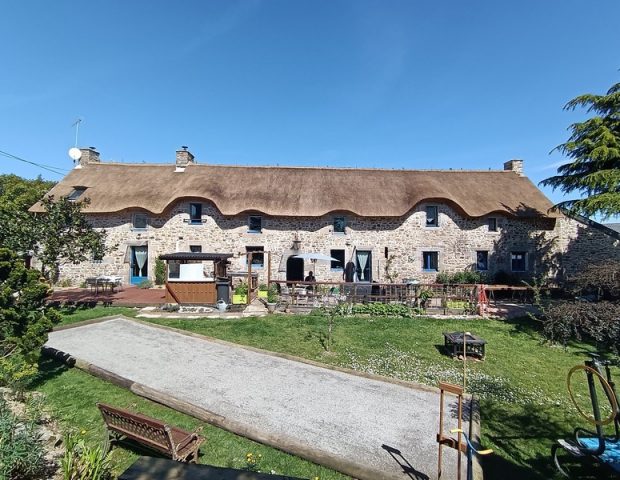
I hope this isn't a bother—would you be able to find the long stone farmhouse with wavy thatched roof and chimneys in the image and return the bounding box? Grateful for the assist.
[31,148,620,284]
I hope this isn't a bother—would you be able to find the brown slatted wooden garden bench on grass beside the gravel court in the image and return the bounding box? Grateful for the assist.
[97,403,204,463]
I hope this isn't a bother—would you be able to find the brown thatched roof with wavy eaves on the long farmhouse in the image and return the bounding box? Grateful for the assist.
[31,163,555,217]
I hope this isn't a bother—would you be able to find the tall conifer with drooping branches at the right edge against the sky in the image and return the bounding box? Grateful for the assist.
[540,83,620,218]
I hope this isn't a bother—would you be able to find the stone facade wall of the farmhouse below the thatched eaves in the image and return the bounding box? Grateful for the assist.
[55,202,620,284]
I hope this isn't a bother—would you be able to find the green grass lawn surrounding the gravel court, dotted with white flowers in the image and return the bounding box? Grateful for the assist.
[38,308,617,480]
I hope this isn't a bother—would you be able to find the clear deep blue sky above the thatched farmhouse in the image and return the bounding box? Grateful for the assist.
[0,0,620,215]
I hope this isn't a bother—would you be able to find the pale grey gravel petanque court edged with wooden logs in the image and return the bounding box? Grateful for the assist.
[46,317,468,480]
